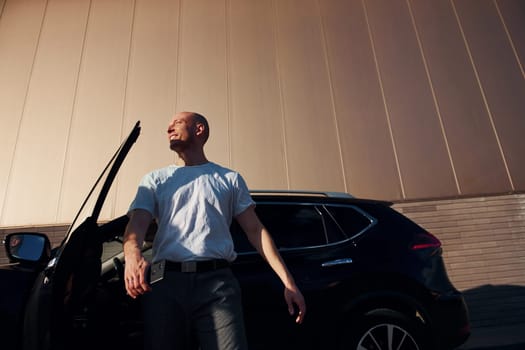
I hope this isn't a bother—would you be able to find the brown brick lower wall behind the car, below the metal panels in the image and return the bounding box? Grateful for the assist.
[0,194,525,327]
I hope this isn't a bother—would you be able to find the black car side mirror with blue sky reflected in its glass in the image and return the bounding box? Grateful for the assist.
[4,232,51,263]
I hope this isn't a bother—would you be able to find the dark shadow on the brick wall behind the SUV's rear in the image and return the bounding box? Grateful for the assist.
[463,284,525,328]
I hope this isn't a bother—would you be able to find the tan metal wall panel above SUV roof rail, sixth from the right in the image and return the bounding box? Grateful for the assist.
[275,0,346,191]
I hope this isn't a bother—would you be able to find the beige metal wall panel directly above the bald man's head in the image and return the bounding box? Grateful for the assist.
[177,0,231,166]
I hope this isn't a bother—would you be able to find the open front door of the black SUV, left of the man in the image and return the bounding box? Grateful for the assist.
[23,122,140,350]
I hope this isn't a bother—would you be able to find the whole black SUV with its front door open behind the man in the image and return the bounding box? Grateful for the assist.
[0,123,470,350]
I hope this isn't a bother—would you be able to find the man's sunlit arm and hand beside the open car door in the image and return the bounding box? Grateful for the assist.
[123,209,153,298]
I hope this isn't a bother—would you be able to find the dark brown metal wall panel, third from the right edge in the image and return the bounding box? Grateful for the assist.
[410,1,510,195]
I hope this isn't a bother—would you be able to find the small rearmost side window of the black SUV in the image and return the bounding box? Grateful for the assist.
[325,205,375,238]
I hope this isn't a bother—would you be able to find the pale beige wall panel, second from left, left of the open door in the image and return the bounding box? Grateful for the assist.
[4,0,89,224]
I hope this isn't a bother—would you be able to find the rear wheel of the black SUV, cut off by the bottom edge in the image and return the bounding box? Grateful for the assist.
[340,309,429,350]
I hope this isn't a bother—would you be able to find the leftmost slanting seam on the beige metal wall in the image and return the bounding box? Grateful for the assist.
[0,0,49,222]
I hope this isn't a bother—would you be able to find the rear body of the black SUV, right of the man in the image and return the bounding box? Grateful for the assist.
[232,192,470,350]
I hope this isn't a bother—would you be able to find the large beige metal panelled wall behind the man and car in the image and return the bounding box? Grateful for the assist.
[0,0,525,227]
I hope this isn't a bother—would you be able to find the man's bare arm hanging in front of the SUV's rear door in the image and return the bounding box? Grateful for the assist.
[235,206,306,323]
